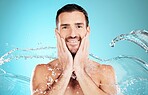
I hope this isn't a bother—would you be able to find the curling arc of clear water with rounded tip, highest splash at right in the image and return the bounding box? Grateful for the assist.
[110,30,148,52]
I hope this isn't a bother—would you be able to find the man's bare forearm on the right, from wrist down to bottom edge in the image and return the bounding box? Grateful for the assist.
[76,70,107,95]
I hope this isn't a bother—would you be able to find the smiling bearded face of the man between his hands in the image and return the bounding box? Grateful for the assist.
[56,11,90,54]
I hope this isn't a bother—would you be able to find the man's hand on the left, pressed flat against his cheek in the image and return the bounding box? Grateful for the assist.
[55,32,73,69]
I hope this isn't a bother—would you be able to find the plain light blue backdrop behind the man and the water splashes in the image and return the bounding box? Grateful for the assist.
[0,0,148,94]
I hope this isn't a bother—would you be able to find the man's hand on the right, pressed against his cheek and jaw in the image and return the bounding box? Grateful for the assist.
[74,32,89,72]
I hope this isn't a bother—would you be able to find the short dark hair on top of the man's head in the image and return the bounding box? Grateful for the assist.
[56,4,89,26]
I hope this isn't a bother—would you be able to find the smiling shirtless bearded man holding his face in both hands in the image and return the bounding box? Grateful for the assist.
[32,4,116,95]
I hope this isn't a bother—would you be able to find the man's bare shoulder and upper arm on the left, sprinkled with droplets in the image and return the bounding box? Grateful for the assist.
[31,60,60,93]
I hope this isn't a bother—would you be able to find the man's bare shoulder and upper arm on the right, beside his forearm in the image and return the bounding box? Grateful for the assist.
[89,61,117,95]
